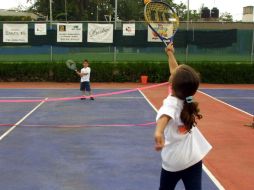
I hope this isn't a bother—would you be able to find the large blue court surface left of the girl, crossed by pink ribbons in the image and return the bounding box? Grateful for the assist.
[0,89,218,190]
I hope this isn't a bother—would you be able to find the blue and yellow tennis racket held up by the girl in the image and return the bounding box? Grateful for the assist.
[144,1,179,46]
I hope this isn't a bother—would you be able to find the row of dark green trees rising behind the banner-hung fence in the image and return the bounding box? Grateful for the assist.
[27,0,199,21]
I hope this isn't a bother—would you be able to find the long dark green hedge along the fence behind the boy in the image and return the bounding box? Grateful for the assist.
[0,62,254,84]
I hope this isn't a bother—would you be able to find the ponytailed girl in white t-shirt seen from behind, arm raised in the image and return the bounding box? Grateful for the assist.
[154,43,212,190]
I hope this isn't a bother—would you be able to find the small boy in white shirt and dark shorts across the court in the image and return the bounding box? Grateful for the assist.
[76,59,94,100]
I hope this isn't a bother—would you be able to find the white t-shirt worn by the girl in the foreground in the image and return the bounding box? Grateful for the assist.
[156,95,212,172]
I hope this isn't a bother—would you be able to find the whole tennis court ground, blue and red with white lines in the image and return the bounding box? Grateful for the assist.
[0,84,254,190]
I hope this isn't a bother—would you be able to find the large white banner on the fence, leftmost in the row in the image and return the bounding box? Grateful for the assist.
[3,24,28,43]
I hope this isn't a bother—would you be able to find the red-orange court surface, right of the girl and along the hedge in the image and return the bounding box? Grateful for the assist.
[0,82,254,190]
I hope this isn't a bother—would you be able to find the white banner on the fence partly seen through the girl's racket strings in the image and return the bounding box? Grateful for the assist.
[147,23,173,42]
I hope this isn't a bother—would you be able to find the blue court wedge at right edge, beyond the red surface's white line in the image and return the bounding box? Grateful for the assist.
[200,89,254,115]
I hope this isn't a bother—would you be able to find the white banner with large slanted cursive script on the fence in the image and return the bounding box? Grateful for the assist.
[87,23,113,43]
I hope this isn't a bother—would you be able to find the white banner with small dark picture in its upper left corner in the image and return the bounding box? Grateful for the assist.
[57,23,83,42]
